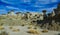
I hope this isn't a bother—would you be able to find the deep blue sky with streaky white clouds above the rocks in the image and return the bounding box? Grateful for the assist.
[0,0,60,14]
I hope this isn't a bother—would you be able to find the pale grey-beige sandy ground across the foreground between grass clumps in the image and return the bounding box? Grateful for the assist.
[0,26,60,35]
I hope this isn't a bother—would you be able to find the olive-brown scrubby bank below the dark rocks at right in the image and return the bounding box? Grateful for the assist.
[40,23,60,31]
